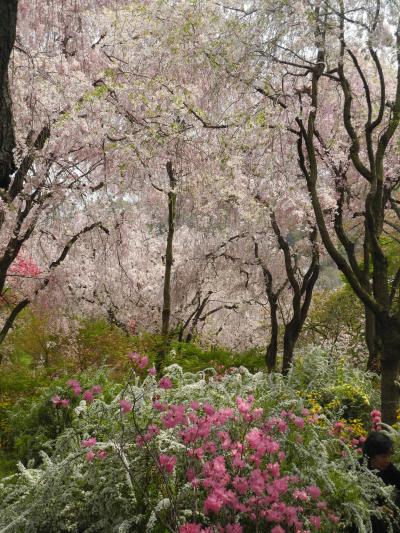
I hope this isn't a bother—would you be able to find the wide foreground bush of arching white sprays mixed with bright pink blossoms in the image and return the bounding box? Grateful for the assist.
[0,358,394,533]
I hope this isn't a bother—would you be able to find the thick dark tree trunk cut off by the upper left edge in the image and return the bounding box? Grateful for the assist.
[0,0,18,190]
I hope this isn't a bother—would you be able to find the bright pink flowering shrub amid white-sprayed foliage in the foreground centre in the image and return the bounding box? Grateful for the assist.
[142,396,339,532]
